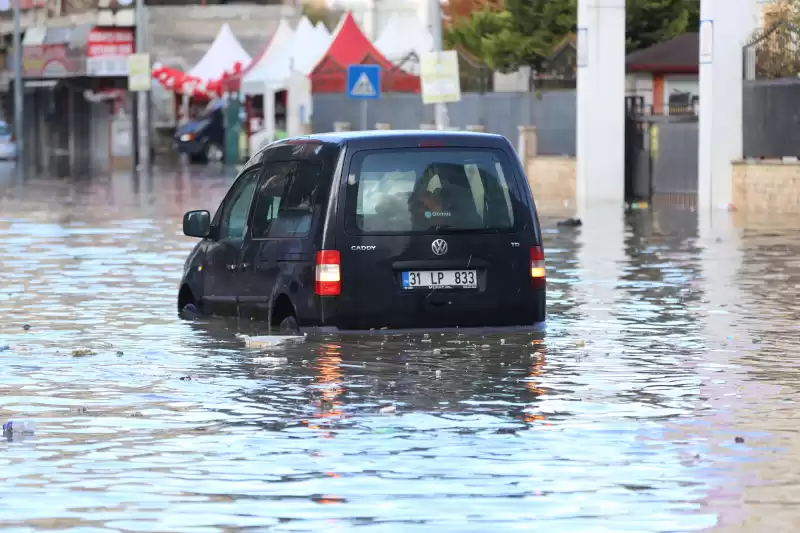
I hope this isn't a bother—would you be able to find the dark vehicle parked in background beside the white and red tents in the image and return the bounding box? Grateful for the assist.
[173,100,225,162]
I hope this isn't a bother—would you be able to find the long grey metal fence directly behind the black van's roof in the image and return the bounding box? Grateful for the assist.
[312,90,576,156]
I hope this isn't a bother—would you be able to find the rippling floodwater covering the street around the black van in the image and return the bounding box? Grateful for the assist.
[0,164,800,533]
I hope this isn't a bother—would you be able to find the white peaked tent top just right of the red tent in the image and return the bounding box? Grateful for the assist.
[375,14,433,75]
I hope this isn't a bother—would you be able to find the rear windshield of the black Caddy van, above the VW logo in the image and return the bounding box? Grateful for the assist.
[345,148,514,234]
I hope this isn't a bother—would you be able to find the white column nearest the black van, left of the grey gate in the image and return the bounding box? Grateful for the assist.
[576,0,625,210]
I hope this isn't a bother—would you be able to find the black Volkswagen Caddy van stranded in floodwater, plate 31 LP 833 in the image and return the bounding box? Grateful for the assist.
[178,131,545,332]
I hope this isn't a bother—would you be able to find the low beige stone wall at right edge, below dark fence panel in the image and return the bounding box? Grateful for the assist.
[733,160,800,217]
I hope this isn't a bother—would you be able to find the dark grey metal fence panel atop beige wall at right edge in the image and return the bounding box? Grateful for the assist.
[742,78,800,158]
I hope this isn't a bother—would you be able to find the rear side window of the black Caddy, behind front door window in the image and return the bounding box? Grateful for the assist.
[252,161,322,239]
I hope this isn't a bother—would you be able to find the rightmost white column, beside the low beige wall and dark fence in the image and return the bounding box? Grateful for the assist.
[697,0,761,216]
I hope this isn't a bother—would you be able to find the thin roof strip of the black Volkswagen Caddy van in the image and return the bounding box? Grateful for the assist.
[265,130,508,148]
